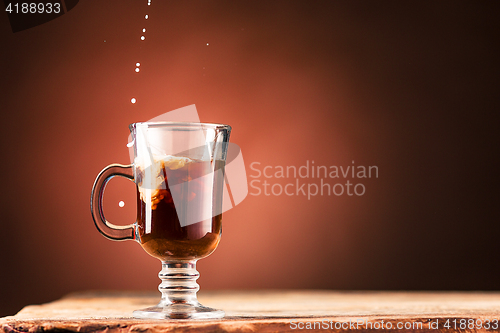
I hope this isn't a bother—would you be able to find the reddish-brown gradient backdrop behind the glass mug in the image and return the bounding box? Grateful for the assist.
[0,0,500,316]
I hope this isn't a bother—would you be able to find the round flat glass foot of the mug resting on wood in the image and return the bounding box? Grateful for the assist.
[134,303,225,319]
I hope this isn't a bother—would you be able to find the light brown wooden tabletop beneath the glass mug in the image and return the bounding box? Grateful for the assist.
[0,290,500,333]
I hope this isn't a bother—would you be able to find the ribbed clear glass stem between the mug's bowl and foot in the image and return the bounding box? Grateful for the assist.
[158,260,200,306]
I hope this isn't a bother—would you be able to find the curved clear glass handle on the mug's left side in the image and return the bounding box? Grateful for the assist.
[90,164,135,240]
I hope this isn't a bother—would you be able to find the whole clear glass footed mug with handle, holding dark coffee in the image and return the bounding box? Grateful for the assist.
[90,122,231,319]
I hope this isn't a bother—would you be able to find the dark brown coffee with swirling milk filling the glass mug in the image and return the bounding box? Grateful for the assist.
[136,156,223,261]
